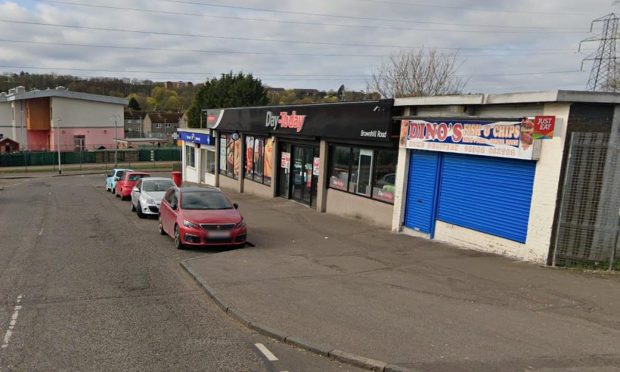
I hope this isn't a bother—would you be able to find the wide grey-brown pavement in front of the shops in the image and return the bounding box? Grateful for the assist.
[182,193,620,371]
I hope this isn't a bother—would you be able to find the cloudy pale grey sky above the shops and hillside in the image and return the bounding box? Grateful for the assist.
[0,0,620,92]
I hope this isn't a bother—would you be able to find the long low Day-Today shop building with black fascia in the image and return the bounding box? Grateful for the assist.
[179,100,398,227]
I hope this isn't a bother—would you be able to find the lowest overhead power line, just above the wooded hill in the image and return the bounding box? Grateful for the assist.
[0,65,582,81]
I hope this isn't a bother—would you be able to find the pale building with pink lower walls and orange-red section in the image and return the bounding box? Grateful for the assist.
[0,86,128,151]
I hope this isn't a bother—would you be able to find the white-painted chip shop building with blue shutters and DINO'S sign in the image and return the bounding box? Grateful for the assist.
[392,91,620,263]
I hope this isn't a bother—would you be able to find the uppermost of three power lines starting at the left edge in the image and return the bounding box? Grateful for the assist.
[0,19,588,52]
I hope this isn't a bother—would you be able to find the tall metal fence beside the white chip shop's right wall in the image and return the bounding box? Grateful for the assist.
[553,133,620,270]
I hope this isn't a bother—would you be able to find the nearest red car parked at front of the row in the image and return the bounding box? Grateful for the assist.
[159,187,248,249]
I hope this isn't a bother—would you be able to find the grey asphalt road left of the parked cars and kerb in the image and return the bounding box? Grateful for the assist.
[0,175,364,371]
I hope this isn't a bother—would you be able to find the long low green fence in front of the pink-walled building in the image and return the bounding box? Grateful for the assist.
[0,148,181,167]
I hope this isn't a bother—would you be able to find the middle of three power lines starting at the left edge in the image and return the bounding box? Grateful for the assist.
[0,39,588,58]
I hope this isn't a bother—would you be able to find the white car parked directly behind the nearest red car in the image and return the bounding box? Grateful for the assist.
[131,177,174,218]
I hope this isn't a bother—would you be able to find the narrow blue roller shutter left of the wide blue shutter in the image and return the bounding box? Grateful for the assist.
[404,151,440,234]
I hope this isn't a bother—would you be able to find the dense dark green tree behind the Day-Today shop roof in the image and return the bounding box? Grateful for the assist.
[187,72,269,128]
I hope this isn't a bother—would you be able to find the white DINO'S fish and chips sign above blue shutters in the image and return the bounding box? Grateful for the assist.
[400,118,540,160]
